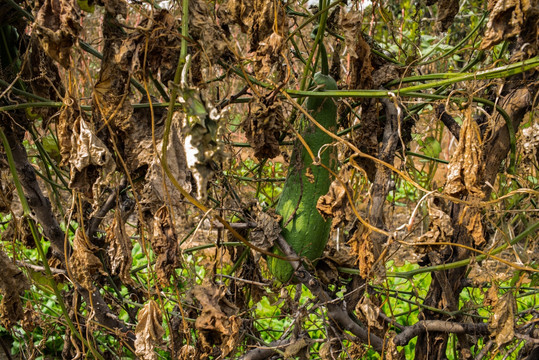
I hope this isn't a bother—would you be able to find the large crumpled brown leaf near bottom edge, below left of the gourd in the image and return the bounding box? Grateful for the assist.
[193,284,241,358]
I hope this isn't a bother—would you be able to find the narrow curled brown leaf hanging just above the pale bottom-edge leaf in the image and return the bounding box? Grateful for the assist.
[151,205,180,286]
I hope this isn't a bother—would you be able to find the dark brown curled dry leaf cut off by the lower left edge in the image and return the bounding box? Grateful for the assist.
[0,250,30,330]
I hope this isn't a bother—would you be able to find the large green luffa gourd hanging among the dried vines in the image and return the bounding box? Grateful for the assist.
[268,73,337,282]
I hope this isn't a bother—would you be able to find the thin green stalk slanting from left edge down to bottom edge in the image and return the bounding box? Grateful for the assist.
[0,127,104,360]
